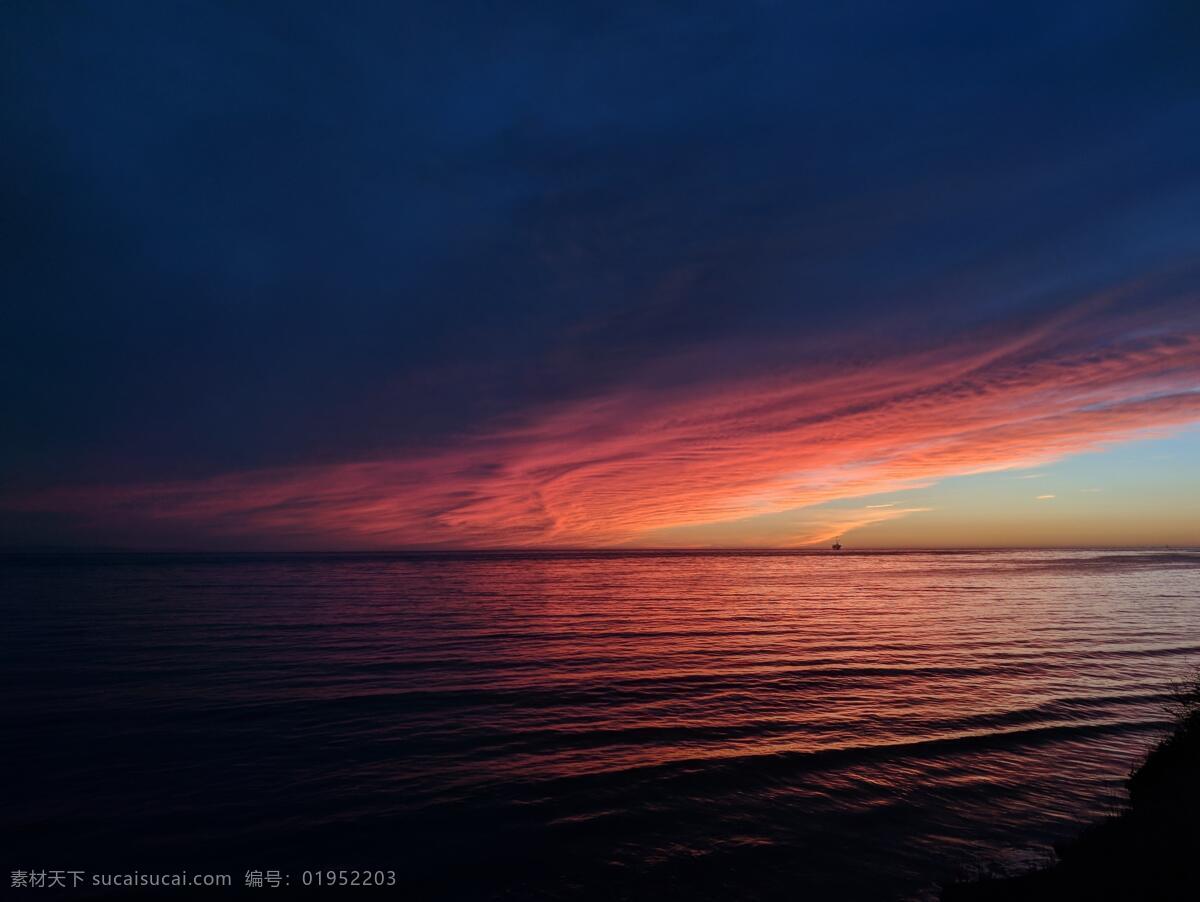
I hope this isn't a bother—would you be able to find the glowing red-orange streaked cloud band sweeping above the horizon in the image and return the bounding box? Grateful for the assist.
[6,304,1200,548]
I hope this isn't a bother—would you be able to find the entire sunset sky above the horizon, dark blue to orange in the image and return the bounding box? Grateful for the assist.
[7,0,1200,549]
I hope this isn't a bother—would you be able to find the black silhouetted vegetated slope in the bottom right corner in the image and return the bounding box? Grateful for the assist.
[942,671,1200,902]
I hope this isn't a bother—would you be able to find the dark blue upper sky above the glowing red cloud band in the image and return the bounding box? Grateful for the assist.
[0,2,1200,539]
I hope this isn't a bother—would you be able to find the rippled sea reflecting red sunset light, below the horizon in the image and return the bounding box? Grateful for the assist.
[0,552,1200,900]
